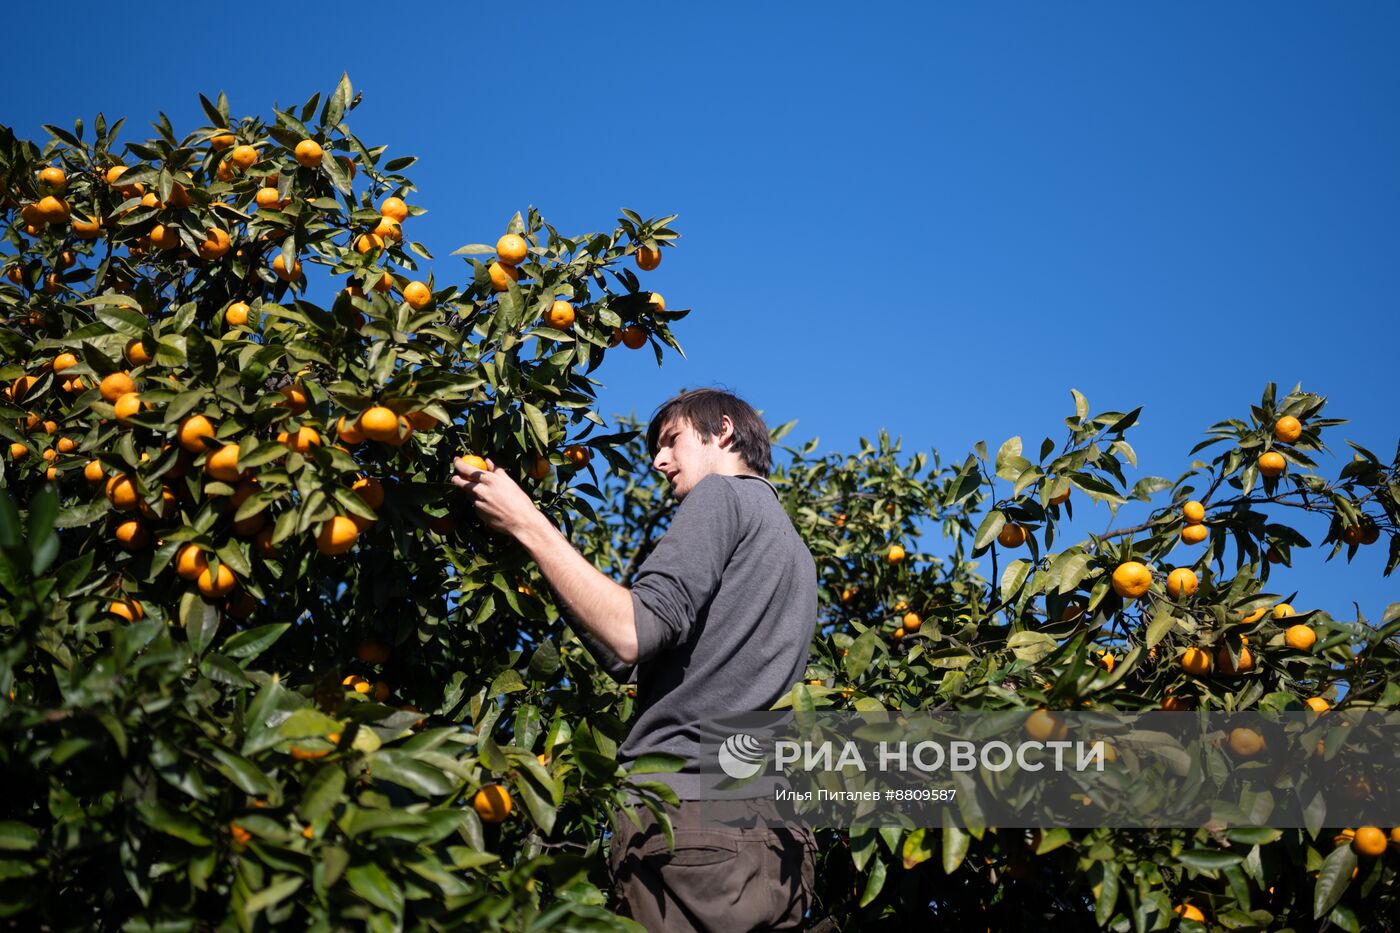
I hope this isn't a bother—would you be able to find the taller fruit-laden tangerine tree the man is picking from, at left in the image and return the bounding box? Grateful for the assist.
[0,80,686,929]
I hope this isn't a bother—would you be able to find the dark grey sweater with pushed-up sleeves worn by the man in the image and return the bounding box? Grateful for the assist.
[575,474,816,800]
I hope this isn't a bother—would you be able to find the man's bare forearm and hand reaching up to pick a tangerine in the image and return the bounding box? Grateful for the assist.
[452,458,637,664]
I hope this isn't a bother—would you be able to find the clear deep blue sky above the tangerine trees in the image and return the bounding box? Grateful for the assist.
[0,3,1400,619]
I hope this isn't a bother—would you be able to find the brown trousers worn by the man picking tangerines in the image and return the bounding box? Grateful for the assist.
[608,800,816,933]
